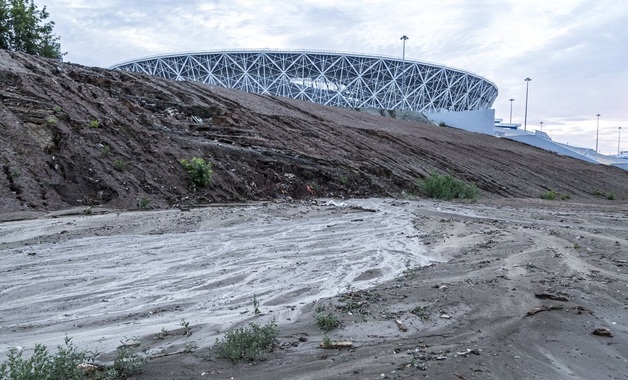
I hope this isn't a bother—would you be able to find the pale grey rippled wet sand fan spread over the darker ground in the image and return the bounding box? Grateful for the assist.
[0,199,434,360]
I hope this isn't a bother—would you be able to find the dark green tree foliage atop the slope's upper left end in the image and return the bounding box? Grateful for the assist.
[0,0,63,59]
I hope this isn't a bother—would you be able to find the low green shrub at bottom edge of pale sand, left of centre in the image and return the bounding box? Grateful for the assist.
[215,320,279,363]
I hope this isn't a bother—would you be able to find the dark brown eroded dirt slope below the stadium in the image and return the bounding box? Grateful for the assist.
[0,51,628,213]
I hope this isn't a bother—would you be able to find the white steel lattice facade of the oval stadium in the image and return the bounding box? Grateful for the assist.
[112,50,497,112]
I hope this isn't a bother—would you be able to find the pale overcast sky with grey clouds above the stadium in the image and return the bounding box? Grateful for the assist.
[44,0,628,154]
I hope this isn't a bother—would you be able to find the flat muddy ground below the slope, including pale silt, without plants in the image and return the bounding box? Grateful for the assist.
[0,199,628,379]
